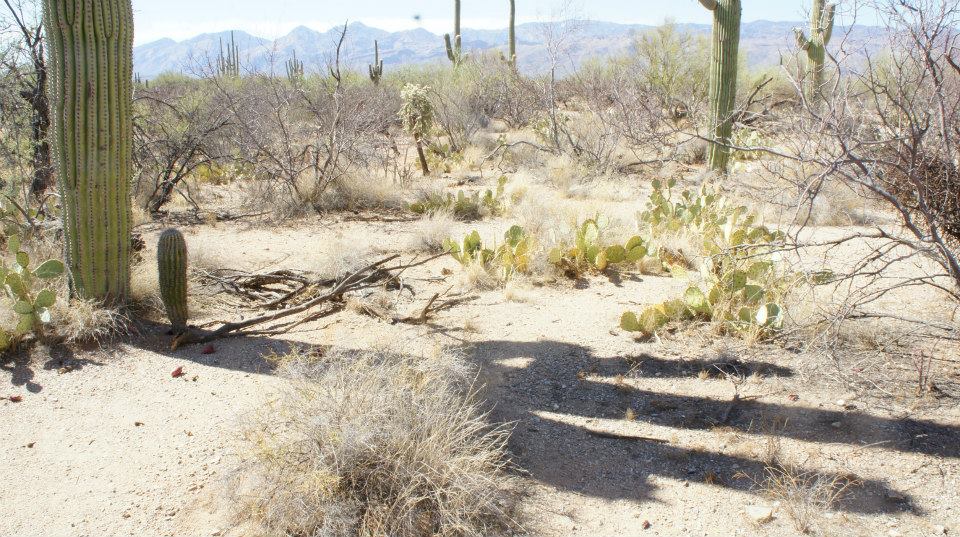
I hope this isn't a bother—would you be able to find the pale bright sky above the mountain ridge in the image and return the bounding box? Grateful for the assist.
[133,0,860,44]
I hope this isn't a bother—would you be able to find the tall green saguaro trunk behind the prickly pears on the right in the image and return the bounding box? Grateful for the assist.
[700,0,742,173]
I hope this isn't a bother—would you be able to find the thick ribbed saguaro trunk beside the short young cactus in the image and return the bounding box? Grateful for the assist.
[43,0,133,304]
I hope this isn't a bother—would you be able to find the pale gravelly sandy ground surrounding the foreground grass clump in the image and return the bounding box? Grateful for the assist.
[0,178,960,537]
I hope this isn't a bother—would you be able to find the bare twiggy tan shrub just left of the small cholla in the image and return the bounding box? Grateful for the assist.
[212,73,400,217]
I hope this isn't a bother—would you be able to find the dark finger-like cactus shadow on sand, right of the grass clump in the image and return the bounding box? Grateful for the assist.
[467,341,960,513]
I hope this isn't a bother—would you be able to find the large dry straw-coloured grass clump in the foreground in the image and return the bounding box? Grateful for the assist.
[236,350,517,537]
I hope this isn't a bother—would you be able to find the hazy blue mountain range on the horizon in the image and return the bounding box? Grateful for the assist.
[133,21,884,79]
